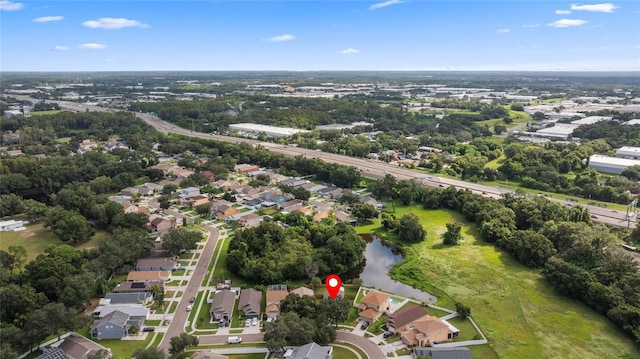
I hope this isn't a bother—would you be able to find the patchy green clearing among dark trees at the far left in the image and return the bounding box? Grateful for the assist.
[0,223,108,262]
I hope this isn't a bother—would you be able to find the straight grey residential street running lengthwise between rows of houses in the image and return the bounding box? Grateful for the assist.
[149,199,221,353]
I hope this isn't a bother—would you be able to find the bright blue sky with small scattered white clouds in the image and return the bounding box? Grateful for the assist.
[0,0,640,71]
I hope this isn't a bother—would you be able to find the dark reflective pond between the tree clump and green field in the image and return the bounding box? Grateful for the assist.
[348,237,437,303]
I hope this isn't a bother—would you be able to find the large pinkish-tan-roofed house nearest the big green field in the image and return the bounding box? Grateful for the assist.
[396,314,459,347]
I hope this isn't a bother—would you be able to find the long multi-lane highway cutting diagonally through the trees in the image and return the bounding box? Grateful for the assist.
[20,96,636,228]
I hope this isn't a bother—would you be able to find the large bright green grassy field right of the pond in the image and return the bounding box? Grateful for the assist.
[364,205,640,359]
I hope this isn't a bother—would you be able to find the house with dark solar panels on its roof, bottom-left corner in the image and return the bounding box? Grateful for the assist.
[36,332,113,359]
